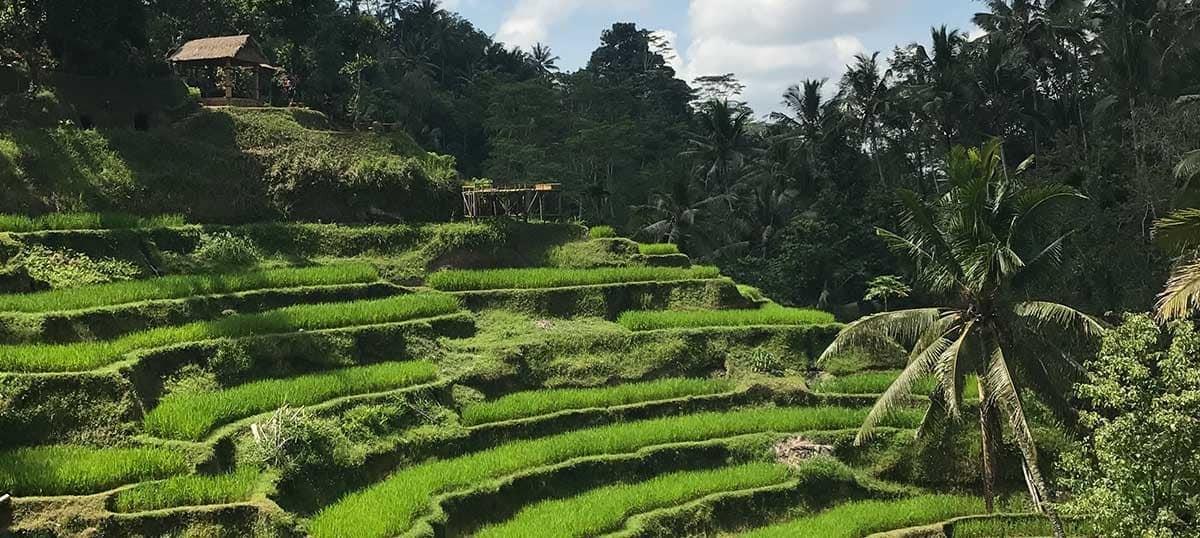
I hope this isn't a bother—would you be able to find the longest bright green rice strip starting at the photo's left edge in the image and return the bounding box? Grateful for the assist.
[0,293,458,372]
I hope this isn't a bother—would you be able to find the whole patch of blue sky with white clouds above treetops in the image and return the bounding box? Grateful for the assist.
[443,0,982,114]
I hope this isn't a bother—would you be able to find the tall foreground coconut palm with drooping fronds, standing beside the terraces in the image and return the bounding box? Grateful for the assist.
[821,142,1103,536]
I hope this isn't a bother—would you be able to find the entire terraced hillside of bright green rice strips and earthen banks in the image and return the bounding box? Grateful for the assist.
[0,223,1085,537]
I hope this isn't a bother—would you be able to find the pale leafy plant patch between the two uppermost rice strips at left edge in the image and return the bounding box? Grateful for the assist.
[11,245,142,289]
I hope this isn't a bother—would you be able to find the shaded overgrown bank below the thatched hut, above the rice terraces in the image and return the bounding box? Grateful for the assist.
[0,108,456,222]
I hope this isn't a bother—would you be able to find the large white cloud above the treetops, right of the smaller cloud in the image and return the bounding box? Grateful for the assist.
[679,0,908,114]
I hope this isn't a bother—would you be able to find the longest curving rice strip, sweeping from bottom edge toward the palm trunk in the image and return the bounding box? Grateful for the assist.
[308,407,920,537]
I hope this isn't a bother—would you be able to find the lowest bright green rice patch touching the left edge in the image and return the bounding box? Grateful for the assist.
[0,444,191,496]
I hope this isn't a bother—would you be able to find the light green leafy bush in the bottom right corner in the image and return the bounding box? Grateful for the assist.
[1064,316,1200,537]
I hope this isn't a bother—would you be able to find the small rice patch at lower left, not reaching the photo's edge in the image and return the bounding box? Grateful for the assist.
[115,468,260,512]
